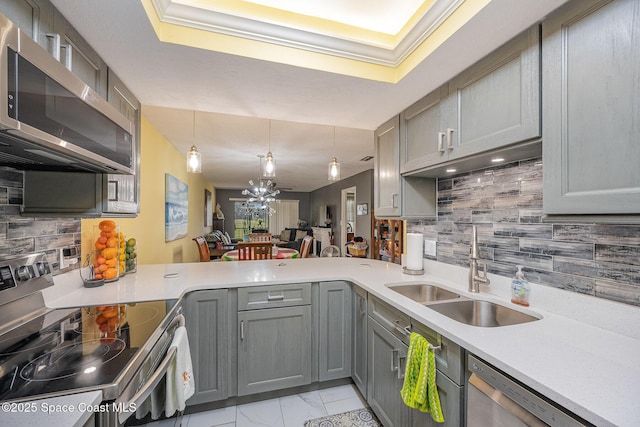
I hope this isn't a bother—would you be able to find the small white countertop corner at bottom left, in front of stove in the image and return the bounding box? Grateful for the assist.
[0,391,106,427]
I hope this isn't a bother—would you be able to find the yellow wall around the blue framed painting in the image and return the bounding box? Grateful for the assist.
[82,117,216,264]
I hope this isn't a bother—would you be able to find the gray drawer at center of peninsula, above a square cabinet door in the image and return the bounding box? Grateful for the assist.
[238,283,311,311]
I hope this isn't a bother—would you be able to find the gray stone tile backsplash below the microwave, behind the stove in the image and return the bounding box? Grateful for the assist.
[0,168,81,274]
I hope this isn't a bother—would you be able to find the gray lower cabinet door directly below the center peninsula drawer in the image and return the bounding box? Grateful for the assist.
[238,305,311,396]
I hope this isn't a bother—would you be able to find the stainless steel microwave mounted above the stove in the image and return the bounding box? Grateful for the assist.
[0,14,135,174]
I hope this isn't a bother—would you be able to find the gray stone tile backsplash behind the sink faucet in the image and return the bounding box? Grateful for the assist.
[407,158,640,305]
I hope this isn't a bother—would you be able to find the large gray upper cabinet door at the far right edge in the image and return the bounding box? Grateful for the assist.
[542,0,640,214]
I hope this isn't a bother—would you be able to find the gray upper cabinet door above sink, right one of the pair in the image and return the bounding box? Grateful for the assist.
[442,26,541,160]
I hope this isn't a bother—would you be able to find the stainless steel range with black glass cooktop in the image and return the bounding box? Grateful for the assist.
[0,254,184,426]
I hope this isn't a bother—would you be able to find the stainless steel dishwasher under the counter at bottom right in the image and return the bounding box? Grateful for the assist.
[467,354,592,427]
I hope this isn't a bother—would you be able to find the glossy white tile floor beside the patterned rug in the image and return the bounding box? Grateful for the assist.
[147,384,366,427]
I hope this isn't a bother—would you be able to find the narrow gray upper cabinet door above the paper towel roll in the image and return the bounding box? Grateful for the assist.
[373,116,402,217]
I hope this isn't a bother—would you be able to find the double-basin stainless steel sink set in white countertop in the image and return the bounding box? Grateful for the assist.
[387,282,539,327]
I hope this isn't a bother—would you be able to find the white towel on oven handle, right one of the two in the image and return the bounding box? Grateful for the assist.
[164,326,196,417]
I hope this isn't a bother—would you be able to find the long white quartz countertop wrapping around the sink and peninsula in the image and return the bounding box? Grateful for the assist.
[44,258,640,427]
